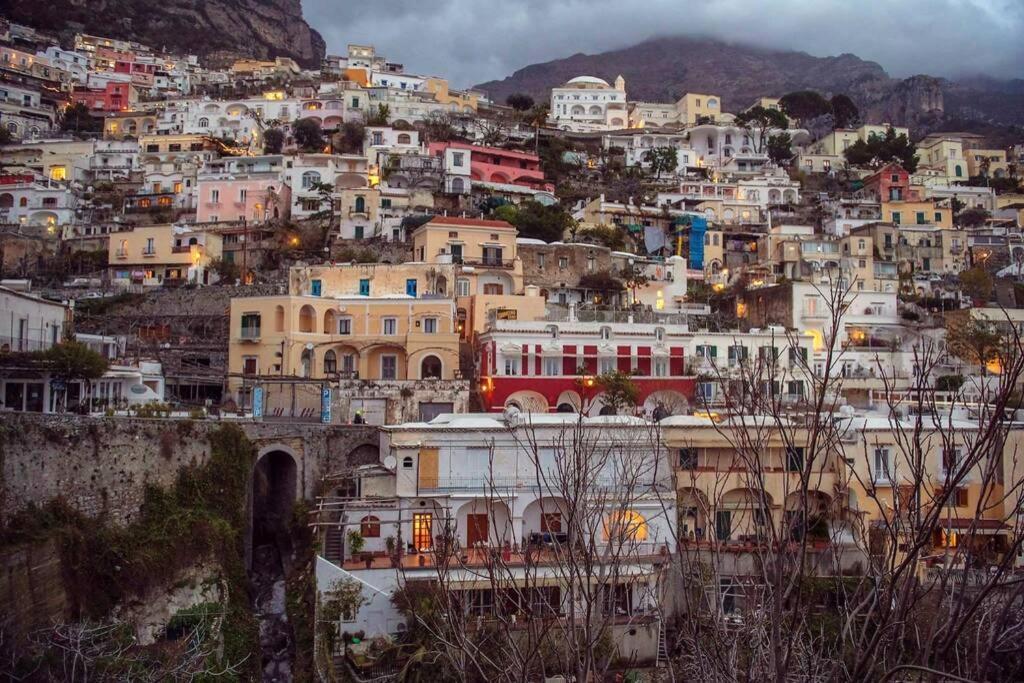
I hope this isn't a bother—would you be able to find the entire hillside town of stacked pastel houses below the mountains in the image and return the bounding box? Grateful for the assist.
[0,20,1024,683]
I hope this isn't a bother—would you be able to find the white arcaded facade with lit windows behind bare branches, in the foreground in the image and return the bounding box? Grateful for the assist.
[316,415,676,637]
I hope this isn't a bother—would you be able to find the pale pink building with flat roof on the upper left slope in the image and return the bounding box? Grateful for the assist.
[196,155,292,223]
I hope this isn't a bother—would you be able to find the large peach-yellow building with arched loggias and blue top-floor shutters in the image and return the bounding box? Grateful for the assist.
[228,263,468,424]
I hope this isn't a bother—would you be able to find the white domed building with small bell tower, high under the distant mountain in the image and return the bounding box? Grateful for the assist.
[548,76,629,132]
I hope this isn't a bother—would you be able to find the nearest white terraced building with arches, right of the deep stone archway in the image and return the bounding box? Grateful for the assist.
[316,415,676,647]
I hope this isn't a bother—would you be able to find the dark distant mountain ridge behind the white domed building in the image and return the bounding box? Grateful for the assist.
[475,37,1024,129]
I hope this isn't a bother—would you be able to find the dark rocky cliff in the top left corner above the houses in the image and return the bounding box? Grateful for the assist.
[4,0,326,68]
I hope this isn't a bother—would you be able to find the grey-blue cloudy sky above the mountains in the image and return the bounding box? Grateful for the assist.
[302,0,1024,86]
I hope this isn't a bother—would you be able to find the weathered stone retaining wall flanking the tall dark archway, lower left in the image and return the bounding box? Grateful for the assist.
[0,414,379,523]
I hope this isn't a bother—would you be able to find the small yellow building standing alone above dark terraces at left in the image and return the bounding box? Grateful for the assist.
[108,225,223,285]
